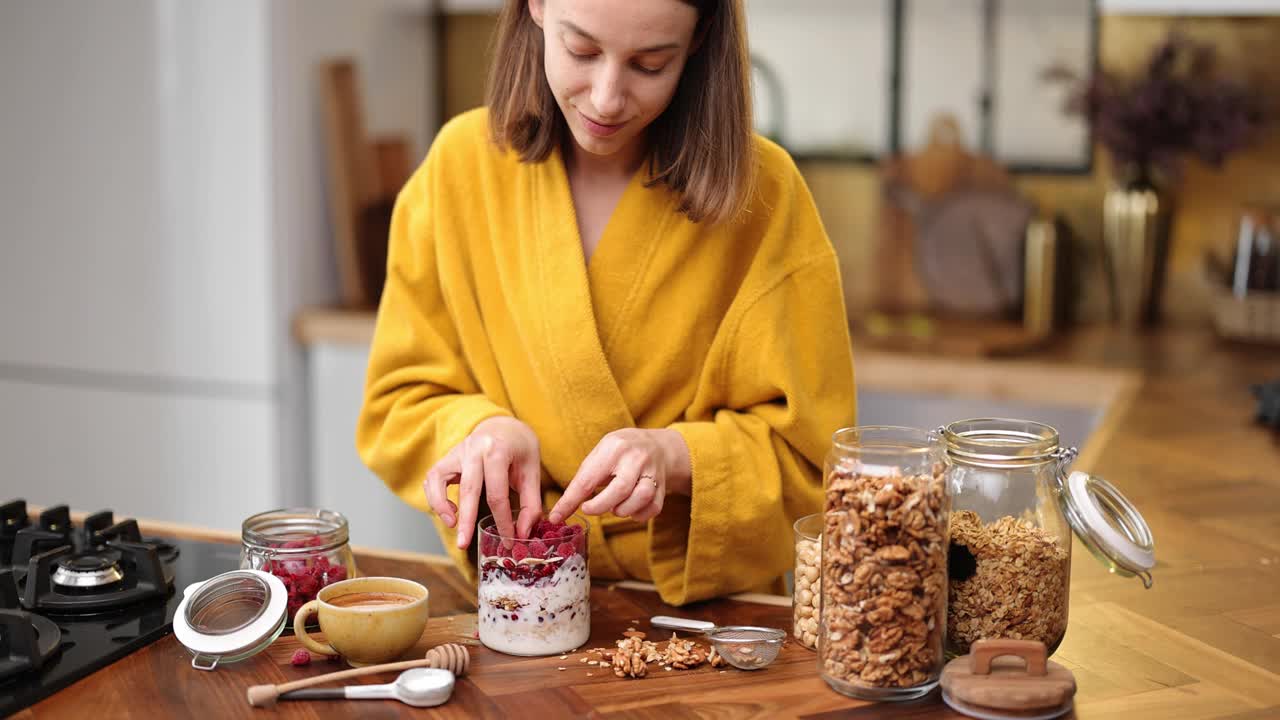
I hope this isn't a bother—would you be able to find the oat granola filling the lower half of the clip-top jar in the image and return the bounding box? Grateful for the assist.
[947,510,1070,653]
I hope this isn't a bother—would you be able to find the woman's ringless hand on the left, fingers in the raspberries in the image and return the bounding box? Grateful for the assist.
[422,416,543,547]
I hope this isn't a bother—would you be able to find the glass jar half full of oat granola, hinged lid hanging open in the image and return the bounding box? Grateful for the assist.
[938,418,1155,656]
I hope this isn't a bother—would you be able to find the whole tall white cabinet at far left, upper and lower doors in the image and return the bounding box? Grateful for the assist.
[0,0,282,527]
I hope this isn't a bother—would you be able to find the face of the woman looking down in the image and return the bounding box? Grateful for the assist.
[529,0,698,163]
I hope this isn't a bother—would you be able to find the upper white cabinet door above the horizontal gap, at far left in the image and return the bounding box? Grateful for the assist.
[0,0,274,389]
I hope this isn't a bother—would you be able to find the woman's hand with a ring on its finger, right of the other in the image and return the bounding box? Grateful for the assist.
[548,428,690,523]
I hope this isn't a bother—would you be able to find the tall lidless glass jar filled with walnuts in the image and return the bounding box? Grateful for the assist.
[818,427,950,700]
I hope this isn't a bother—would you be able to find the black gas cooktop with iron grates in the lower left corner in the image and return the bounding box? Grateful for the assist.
[0,499,230,717]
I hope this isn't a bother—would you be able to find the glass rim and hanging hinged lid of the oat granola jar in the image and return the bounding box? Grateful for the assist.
[938,418,1156,588]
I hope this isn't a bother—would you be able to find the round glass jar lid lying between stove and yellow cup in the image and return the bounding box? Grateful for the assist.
[173,570,289,670]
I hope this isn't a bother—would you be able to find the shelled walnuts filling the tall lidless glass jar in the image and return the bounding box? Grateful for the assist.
[820,465,947,688]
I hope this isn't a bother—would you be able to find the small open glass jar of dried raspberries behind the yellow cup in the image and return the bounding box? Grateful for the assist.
[241,507,358,624]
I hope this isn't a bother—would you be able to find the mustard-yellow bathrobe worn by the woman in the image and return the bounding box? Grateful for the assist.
[356,109,854,605]
